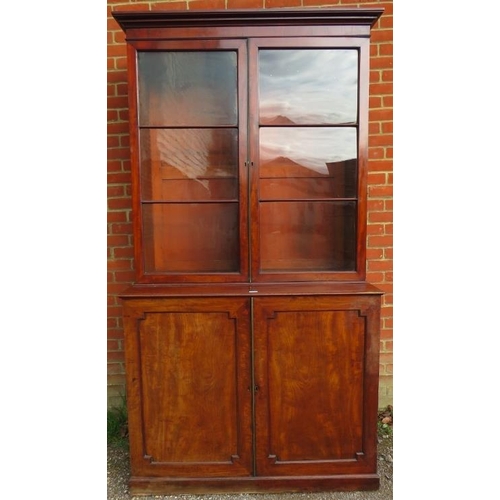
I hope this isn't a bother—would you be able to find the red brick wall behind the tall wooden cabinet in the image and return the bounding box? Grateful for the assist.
[107,0,393,407]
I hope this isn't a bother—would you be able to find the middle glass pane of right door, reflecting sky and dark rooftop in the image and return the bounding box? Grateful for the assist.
[259,127,357,200]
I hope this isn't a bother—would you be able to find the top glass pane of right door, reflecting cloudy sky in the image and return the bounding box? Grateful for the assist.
[259,49,358,125]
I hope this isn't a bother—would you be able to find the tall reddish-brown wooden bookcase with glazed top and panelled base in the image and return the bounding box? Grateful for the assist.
[113,8,382,495]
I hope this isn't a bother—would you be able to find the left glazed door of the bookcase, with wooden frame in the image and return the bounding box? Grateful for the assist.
[131,40,248,282]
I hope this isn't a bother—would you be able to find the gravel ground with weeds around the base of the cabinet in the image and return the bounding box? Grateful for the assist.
[108,437,393,500]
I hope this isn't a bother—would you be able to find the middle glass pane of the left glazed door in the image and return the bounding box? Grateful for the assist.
[140,129,238,201]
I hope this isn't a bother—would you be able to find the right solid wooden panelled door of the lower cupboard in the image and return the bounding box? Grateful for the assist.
[254,296,379,476]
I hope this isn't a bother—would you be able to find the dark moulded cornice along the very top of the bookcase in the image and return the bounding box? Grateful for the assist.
[111,7,384,31]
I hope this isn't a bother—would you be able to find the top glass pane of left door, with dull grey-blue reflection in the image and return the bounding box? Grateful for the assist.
[138,51,237,127]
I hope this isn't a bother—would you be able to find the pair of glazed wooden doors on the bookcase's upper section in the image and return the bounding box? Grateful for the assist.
[130,37,369,283]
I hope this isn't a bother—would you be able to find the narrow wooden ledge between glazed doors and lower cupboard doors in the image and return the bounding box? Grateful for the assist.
[119,282,384,299]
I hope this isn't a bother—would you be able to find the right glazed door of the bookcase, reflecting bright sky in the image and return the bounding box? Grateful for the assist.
[249,38,368,281]
